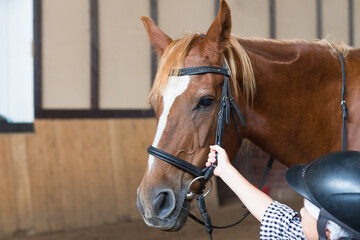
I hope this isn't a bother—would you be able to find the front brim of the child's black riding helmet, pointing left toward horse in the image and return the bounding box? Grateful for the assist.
[286,164,321,208]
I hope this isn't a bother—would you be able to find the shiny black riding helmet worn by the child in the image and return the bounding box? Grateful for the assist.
[286,151,360,239]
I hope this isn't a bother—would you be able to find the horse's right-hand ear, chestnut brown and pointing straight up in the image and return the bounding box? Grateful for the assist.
[206,0,231,52]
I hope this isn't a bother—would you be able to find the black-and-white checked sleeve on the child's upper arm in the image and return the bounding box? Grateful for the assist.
[260,201,305,240]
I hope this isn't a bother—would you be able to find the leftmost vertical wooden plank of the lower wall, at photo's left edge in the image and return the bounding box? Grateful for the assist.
[0,135,18,236]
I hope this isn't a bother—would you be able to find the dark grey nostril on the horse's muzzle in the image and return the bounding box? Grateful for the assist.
[153,189,175,218]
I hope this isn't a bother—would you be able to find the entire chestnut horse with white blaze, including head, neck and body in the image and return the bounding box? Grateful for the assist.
[137,0,360,231]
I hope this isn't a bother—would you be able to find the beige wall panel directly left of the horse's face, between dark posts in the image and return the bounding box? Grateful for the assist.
[99,0,151,109]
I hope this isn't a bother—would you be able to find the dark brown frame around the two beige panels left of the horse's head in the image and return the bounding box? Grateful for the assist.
[33,0,157,119]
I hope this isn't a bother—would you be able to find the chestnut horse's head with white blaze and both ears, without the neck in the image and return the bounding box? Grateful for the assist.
[137,1,252,231]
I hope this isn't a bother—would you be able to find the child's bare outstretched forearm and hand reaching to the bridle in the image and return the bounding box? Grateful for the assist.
[206,145,273,222]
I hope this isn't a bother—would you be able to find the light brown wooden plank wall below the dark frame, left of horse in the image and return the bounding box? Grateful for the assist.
[0,119,156,237]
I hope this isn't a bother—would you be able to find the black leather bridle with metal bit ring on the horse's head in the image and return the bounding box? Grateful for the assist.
[147,55,274,239]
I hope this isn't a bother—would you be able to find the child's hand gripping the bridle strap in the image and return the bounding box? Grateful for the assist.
[206,145,232,177]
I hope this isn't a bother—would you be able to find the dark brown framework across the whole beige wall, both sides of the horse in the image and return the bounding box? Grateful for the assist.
[33,0,354,119]
